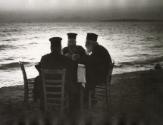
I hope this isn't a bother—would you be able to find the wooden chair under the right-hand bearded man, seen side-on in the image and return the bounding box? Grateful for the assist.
[89,62,114,109]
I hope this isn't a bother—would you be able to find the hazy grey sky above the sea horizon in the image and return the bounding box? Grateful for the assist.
[0,0,163,20]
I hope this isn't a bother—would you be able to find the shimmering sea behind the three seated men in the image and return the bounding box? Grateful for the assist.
[0,22,163,87]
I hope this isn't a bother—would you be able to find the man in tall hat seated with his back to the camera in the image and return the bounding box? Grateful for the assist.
[34,37,75,104]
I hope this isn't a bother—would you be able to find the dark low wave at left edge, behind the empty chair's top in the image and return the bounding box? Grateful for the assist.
[0,62,34,70]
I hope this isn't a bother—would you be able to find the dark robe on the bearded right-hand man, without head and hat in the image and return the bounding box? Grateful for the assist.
[85,45,112,88]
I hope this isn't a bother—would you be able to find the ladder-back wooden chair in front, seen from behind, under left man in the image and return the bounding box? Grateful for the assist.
[41,69,69,113]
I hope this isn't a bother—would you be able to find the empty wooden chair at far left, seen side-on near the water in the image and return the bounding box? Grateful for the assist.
[19,62,34,104]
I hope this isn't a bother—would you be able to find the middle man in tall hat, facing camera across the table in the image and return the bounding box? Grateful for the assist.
[63,33,85,63]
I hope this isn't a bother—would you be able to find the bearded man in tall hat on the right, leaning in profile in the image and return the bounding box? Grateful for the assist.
[85,33,112,104]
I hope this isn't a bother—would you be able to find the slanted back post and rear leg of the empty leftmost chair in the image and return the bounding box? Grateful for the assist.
[19,62,29,103]
